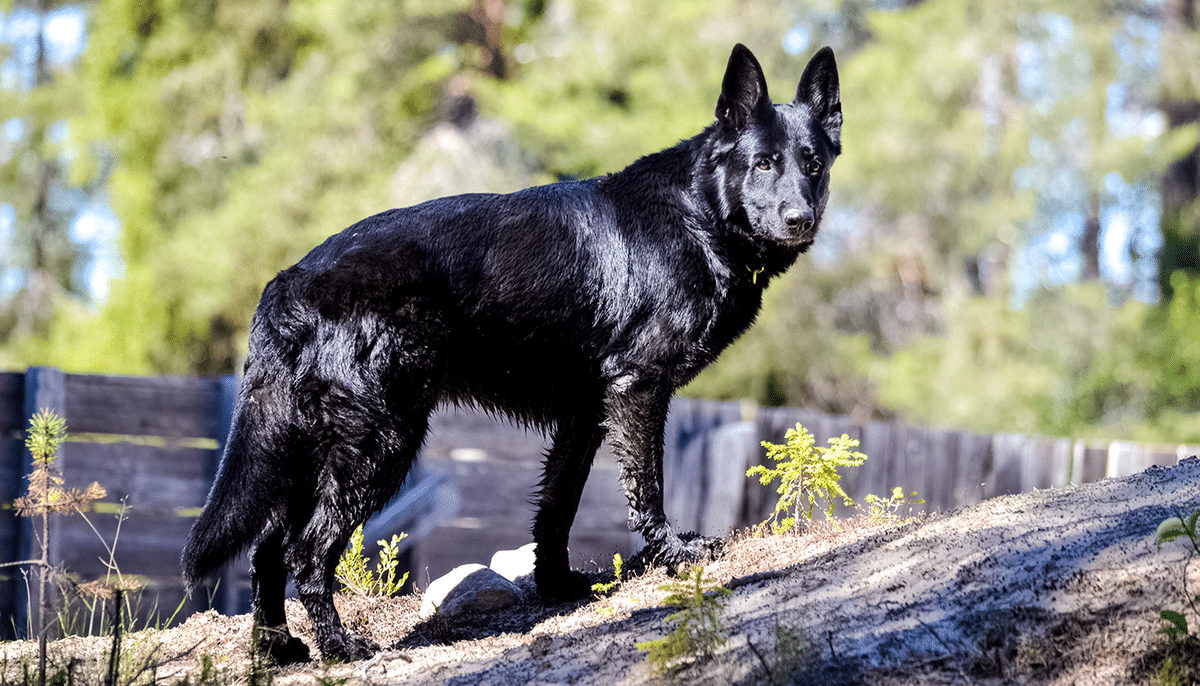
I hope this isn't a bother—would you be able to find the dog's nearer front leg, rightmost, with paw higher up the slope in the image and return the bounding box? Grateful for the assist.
[606,387,720,573]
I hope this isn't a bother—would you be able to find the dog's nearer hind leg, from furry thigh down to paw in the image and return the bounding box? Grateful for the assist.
[284,254,446,661]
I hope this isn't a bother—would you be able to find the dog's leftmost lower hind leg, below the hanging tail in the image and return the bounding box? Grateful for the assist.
[250,530,308,664]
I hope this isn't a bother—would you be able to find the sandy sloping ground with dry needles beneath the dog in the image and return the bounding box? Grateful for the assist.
[0,458,1200,686]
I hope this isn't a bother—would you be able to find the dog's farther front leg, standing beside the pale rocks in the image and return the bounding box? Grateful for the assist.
[533,411,604,600]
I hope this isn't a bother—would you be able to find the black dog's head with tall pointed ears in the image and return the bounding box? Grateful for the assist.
[716,44,841,251]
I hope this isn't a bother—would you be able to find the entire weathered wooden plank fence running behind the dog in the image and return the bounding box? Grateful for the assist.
[0,368,1193,633]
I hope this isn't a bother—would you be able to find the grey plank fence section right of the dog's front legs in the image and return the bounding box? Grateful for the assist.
[665,398,1200,534]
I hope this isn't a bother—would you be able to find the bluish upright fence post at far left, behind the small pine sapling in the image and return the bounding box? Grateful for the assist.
[13,367,71,638]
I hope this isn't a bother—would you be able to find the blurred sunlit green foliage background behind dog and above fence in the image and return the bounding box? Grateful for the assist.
[0,0,1200,441]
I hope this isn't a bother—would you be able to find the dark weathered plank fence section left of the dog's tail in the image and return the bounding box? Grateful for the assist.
[0,368,236,633]
